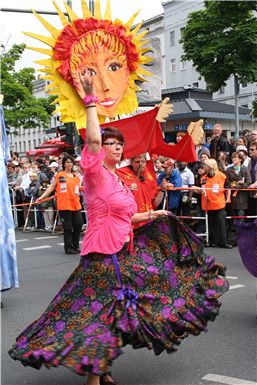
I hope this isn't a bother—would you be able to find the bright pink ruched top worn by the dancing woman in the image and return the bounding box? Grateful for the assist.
[80,146,137,255]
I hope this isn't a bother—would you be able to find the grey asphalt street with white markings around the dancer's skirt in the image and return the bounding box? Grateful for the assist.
[1,230,257,385]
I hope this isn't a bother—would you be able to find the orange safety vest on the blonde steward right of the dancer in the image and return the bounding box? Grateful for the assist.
[201,171,227,210]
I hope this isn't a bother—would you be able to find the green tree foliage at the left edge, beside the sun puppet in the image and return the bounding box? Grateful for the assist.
[1,44,55,129]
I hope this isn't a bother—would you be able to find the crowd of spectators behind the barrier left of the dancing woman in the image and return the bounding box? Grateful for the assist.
[6,152,86,232]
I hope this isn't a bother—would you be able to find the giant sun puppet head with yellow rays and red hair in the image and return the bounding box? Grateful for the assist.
[25,0,152,129]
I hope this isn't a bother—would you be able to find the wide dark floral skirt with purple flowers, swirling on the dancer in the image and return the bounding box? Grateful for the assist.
[9,216,228,375]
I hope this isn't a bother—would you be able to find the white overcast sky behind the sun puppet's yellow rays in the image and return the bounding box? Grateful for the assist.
[0,0,162,69]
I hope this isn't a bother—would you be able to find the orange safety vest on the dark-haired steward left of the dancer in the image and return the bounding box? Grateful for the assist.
[54,171,81,211]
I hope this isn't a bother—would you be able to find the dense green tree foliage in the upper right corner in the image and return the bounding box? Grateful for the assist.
[181,1,257,91]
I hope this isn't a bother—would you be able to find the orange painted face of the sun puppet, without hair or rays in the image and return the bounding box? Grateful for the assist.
[71,46,130,117]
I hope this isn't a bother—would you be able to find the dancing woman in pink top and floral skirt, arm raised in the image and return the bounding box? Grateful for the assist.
[10,74,228,385]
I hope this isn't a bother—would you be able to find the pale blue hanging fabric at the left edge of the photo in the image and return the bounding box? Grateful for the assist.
[0,106,19,290]
